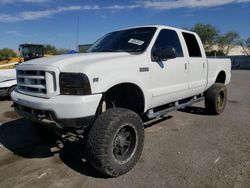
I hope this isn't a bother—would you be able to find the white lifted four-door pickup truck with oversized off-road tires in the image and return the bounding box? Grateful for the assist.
[12,25,231,177]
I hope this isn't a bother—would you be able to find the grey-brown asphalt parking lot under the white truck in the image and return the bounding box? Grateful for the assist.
[0,71,250,188]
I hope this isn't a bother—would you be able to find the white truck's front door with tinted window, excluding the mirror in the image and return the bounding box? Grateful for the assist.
[150,29,188,107]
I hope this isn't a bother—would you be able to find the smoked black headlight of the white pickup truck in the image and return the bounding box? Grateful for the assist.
[59,72,91,95]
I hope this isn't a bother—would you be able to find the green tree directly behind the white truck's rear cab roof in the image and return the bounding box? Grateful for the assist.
[191,23,219,52]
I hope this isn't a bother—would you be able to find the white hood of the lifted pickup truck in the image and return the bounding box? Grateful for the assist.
[22,52,138,72]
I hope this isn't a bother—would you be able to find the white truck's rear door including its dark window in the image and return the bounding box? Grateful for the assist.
[182,32,207,95]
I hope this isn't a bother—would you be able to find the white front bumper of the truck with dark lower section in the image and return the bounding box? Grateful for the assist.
[11,91,102,128]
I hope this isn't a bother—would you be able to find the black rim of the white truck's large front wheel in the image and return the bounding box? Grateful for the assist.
[113,125,137,163]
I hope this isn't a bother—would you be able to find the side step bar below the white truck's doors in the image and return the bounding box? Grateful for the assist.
[147,96,205,119]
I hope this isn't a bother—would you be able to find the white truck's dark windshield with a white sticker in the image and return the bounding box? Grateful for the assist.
[88,27,156,52]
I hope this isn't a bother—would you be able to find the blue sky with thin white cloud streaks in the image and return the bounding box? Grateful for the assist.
[0,0,250,50]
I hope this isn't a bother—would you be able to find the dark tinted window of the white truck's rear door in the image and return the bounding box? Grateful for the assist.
[182,32,202,58]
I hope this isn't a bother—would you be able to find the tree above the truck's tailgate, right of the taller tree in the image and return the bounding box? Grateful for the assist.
[218,31,240,55]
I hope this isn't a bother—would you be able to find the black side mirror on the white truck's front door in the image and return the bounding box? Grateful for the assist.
[153,46,177,61]
